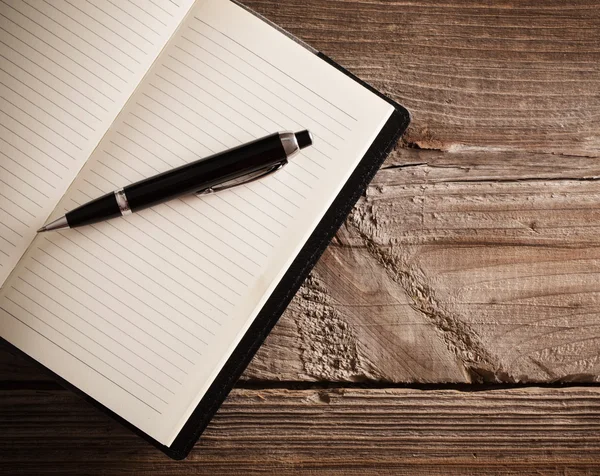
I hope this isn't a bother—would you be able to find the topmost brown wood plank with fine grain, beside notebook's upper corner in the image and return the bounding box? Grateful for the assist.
[245,0,600,157]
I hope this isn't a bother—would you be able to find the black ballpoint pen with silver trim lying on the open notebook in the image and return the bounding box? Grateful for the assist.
[38,130,313,233]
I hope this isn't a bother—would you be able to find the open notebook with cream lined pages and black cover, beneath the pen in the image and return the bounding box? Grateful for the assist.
[0,0,409,458]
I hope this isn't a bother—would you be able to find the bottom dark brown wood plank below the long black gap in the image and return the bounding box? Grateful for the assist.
[0,388,600,476]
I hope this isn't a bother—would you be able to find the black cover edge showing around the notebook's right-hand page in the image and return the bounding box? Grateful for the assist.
[0,8,410,460]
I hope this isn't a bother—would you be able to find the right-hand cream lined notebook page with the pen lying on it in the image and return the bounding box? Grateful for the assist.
[0,0,392,445]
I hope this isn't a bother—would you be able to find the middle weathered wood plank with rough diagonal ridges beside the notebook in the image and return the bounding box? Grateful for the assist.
[0,151,600,382]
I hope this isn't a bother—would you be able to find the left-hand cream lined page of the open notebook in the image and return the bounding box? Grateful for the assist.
[0,0,192,285]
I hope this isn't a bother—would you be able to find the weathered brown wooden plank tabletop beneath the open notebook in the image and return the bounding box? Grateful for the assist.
[0,0,600,475]
